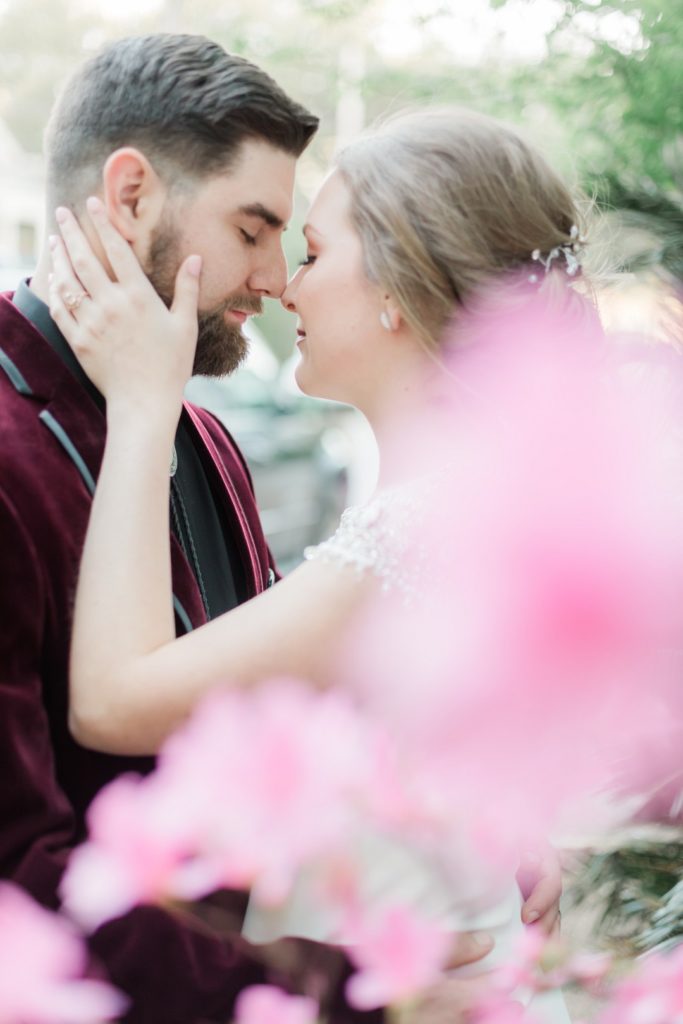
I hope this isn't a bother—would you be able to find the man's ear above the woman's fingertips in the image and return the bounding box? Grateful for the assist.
[102,146,166,246]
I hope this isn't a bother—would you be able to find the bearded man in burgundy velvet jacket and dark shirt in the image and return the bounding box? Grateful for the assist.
[0,36,557,1024]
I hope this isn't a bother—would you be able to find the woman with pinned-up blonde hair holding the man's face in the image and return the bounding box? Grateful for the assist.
[50,111,579,1021]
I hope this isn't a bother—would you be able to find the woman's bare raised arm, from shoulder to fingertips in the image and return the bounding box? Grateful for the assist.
[50,206,372,754]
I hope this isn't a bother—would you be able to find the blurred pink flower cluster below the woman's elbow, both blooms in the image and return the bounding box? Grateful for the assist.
[62,680,373,929]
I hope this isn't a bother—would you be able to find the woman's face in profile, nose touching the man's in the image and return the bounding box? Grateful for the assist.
[283,171,391,410]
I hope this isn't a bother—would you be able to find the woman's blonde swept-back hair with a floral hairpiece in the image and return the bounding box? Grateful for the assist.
[337,109,581,349]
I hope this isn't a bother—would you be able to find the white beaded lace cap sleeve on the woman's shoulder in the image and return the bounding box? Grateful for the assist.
[303,484,425,600]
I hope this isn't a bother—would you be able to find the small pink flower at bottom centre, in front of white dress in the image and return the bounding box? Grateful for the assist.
[346,906,452,1010]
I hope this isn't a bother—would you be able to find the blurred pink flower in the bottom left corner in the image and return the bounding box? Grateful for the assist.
[0,883,127,1024]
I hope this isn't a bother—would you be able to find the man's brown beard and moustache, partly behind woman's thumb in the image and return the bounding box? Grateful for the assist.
[144,216,262,377]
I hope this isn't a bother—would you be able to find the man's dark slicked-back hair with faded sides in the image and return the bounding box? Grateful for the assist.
[46,34,318,205]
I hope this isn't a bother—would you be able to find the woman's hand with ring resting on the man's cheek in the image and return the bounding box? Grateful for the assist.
[50,197,201,419]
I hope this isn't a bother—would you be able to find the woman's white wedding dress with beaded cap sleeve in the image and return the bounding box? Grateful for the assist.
[243,489,570,1024]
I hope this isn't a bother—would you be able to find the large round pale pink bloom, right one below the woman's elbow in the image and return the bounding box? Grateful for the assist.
[160,680,373,902]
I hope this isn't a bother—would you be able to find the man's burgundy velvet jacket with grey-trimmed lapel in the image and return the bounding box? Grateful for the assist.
[0,295,378,1024]
